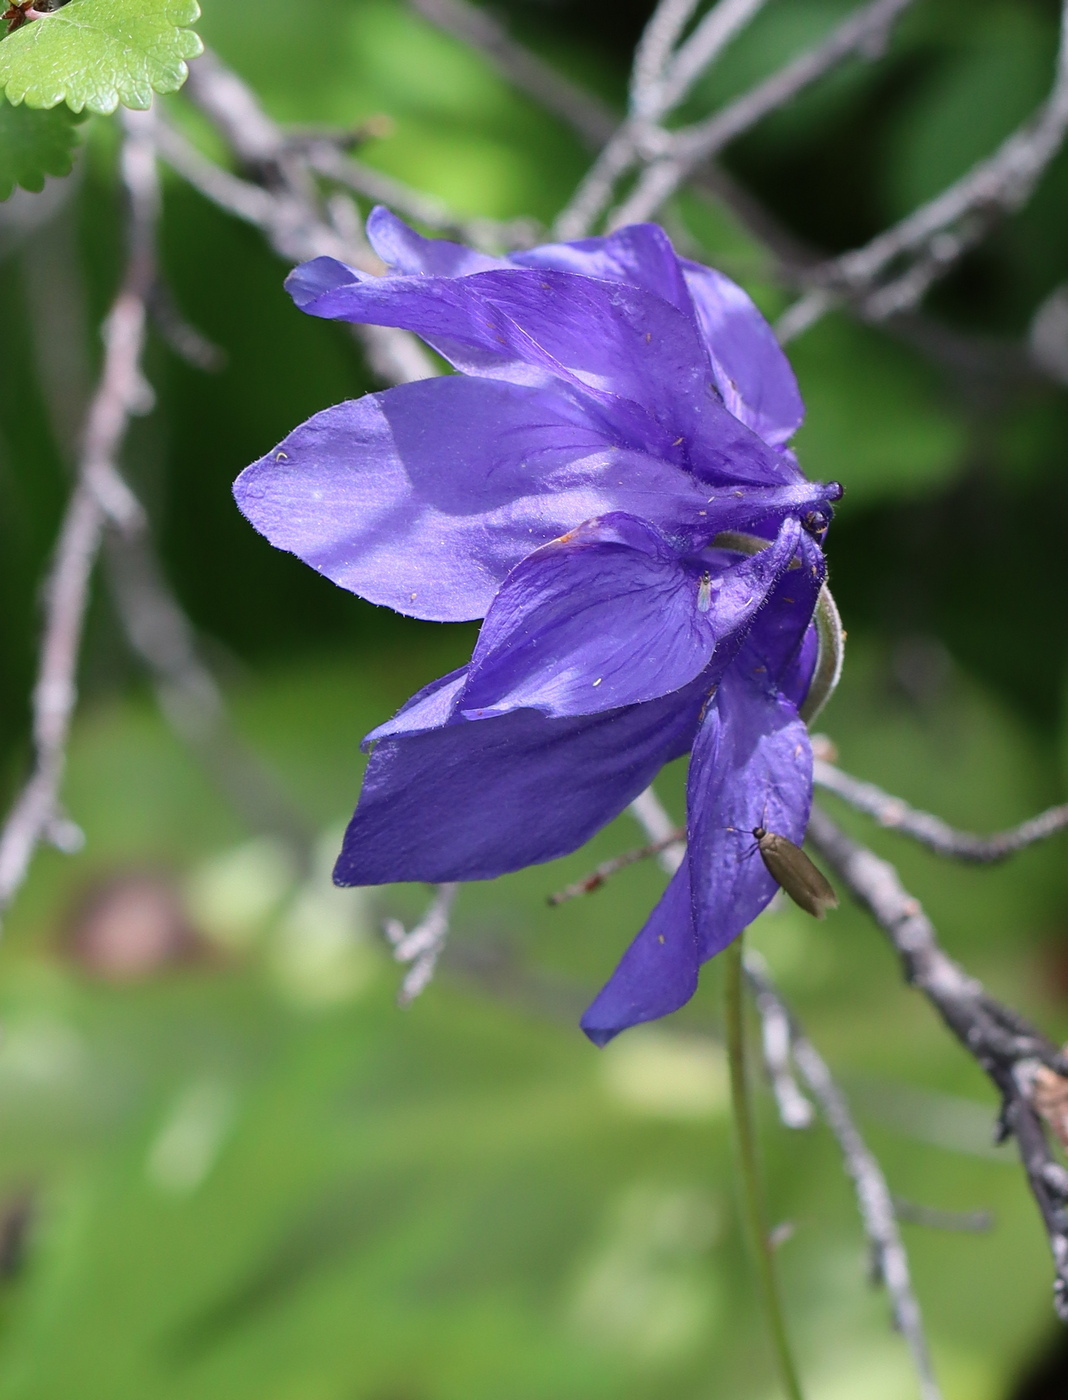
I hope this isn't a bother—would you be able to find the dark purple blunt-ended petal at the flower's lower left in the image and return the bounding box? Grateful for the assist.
[335,679,707,885]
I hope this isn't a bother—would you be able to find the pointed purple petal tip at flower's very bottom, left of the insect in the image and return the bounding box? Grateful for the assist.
[581,858,698,1046]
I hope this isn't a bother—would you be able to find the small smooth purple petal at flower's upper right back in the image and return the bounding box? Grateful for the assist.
[682,259,805,445]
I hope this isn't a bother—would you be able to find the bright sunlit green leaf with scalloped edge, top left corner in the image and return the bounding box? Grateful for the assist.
[0,0,203,112]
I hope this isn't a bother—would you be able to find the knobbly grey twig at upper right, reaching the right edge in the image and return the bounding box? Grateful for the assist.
[777,0,1068,340]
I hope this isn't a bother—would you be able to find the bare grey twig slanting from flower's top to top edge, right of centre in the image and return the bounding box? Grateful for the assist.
[609,0,913,228]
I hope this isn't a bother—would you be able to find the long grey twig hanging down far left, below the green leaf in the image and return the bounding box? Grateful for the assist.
[0,112,160,914]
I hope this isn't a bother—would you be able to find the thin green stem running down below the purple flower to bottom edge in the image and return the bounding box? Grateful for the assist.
[724,938,803,1400]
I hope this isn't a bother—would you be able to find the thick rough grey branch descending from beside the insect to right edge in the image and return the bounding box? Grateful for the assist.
[808,808,1068,1322]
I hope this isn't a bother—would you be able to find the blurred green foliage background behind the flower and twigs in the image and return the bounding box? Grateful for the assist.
[0,0,1068,1400]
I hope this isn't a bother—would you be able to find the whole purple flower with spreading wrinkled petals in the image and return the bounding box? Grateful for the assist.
[235,209,840,1044]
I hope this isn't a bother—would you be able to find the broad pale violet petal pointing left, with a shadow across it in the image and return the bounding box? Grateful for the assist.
[234,375,733,622]
